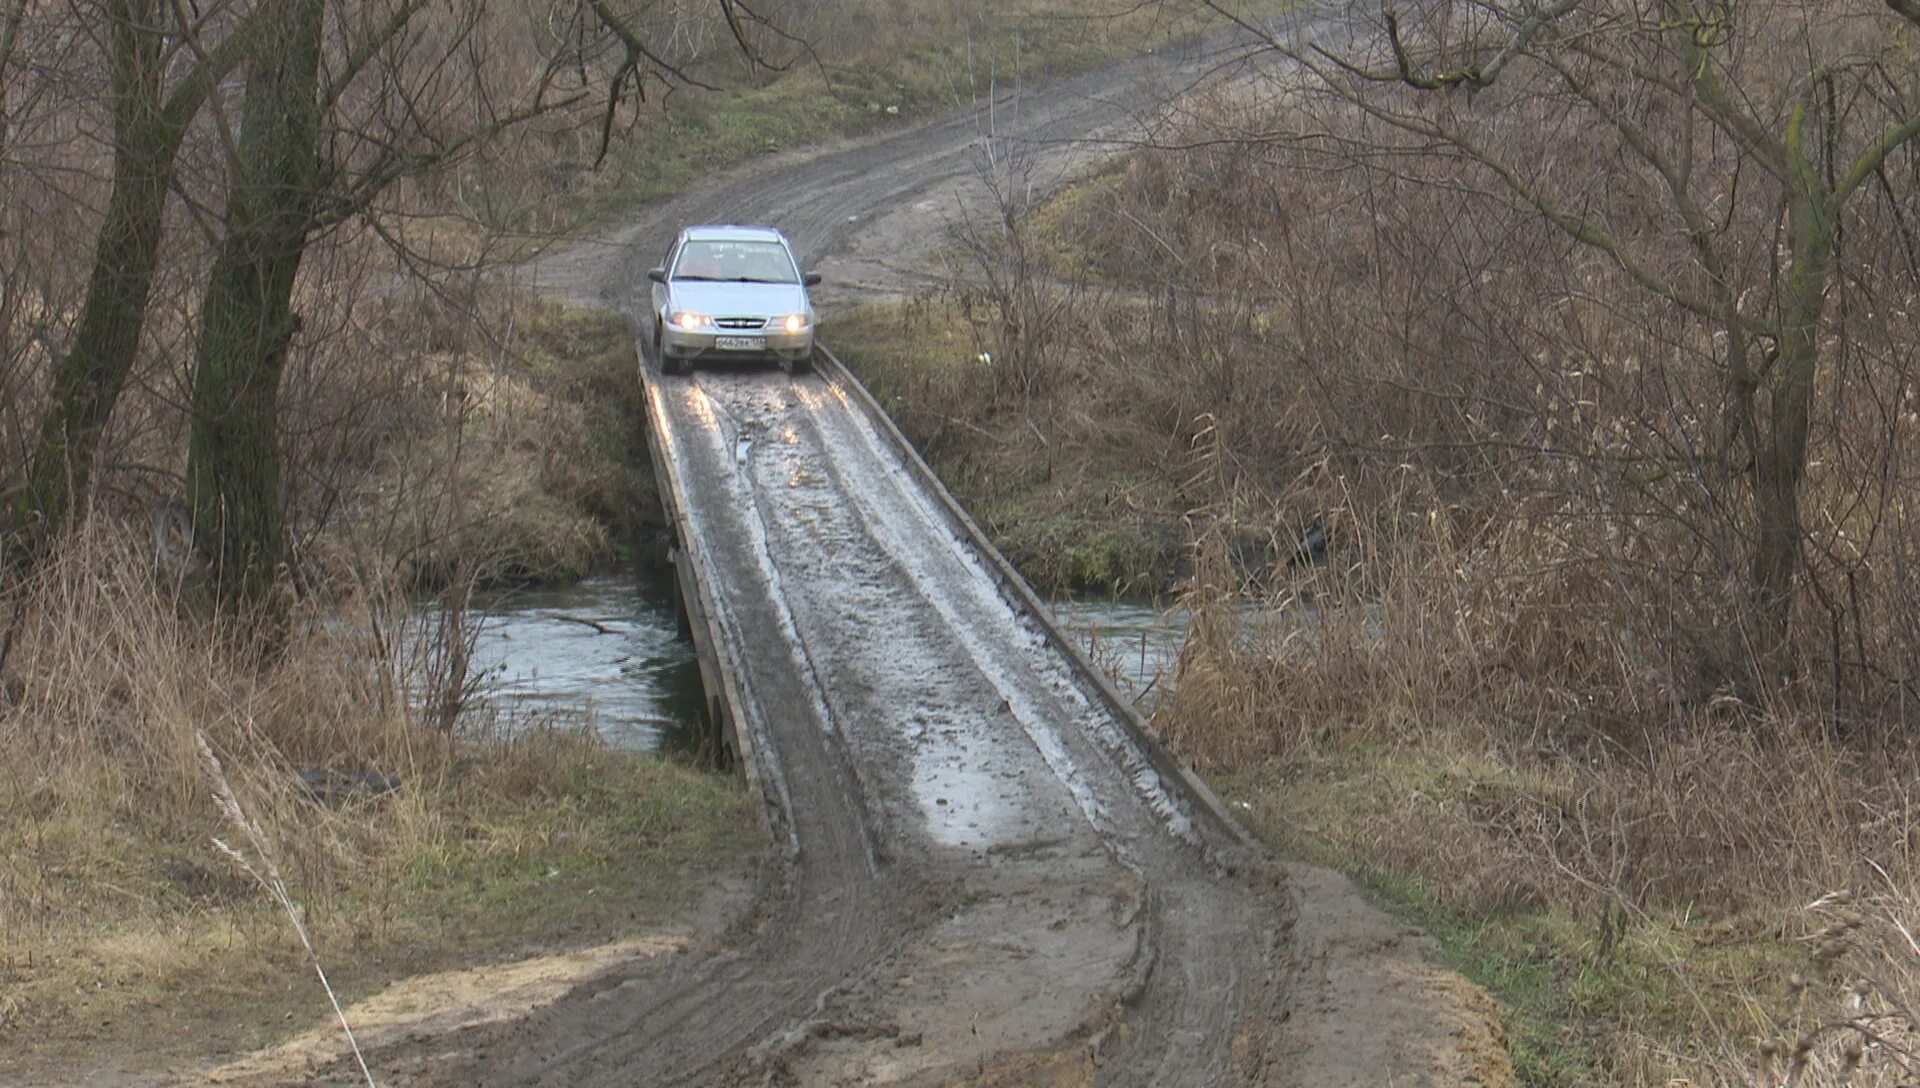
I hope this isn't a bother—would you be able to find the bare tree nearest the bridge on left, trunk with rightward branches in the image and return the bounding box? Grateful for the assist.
[186,0,802,606]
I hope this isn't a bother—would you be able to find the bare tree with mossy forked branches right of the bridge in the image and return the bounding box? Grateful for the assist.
[1215,0,1920,675]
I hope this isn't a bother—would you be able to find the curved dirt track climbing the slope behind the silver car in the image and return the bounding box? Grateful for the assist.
[526,4,1346,315]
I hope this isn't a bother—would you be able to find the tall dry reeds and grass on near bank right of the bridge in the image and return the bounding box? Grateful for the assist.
[1156,464,1920,1086]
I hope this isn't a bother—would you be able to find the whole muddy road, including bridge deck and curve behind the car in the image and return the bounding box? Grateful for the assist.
[243,15,1503,1088]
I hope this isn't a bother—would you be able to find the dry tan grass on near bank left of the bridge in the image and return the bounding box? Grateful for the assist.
[0,526,758,1082]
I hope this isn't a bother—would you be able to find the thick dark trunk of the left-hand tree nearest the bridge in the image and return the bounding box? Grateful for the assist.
[186,0,324,610]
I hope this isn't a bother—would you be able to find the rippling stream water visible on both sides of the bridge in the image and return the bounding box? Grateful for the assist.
[470,570,1187,752]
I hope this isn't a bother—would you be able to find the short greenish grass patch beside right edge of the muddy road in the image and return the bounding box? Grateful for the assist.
[1213,746,1809,1088]
